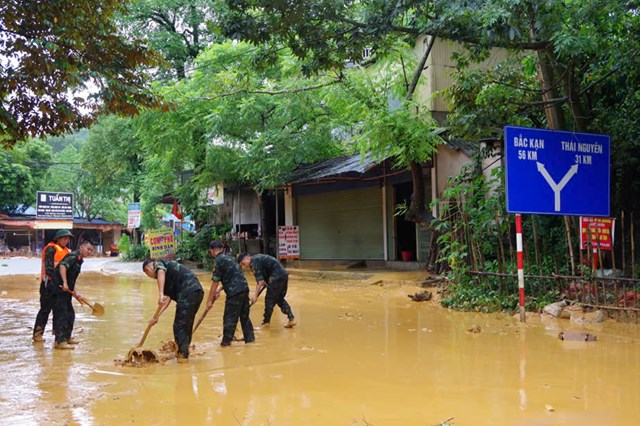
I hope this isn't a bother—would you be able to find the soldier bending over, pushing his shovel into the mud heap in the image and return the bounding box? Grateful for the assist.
[142,259,204,362]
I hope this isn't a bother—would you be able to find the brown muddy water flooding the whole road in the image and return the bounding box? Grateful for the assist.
[0,271,640,426]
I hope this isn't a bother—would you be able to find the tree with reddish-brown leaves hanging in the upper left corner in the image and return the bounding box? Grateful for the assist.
[0,0,158,146]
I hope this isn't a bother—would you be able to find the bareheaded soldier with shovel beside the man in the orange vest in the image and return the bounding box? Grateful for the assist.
[49,241,93,349]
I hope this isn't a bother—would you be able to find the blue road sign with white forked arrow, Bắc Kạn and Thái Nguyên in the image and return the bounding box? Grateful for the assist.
[504,126,610,216]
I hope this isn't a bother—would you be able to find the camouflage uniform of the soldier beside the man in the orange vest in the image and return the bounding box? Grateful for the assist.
[48,251,84,343]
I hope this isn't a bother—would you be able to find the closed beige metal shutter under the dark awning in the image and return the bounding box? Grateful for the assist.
[296,187,384,259]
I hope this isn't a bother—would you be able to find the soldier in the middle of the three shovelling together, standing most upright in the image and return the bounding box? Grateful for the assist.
[207,240,256,346]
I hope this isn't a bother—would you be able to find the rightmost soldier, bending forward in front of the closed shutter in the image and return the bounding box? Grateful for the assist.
[238,253,296,328]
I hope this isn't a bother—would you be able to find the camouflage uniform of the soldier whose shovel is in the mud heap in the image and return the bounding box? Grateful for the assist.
[154,260,204,358]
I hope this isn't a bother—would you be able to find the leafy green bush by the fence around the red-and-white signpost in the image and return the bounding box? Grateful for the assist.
[436,158,570,312]
